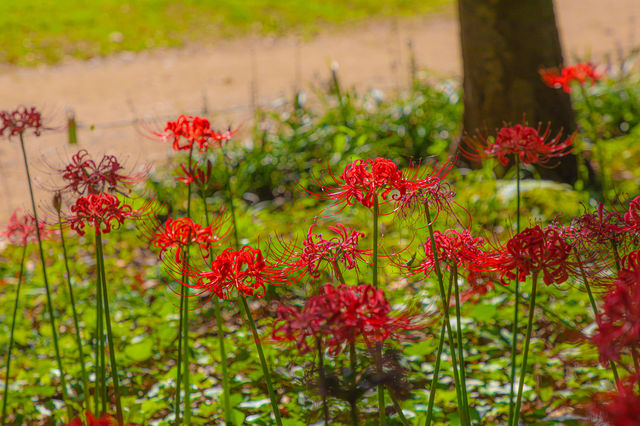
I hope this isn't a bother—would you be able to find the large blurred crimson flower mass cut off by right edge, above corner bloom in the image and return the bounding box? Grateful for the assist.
[591,251,640,364]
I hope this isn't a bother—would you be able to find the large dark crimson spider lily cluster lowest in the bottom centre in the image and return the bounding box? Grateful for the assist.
[272,284,419,355]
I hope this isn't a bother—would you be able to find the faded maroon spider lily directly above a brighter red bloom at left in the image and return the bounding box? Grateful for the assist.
[59,149,148,195]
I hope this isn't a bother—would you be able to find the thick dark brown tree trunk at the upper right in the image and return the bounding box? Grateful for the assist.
[458,0,577,183]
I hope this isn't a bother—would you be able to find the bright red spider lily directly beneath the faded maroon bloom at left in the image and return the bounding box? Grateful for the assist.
[65,192,151,235]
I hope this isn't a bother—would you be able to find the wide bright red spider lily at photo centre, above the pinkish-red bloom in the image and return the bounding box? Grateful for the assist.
[303,157,451,212]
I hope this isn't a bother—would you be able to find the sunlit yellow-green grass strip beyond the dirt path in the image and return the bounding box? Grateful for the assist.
[0,0,451,65]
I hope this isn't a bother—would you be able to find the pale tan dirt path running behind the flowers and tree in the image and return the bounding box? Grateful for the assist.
[0,0,640,220]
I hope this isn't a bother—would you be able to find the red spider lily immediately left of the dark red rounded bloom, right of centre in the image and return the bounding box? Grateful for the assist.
[414,229,491,276]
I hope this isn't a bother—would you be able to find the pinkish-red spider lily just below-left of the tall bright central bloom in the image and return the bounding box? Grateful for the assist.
[268,223,371,279]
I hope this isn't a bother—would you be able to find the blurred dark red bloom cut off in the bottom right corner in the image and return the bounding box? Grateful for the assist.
[589,374,640,426]
